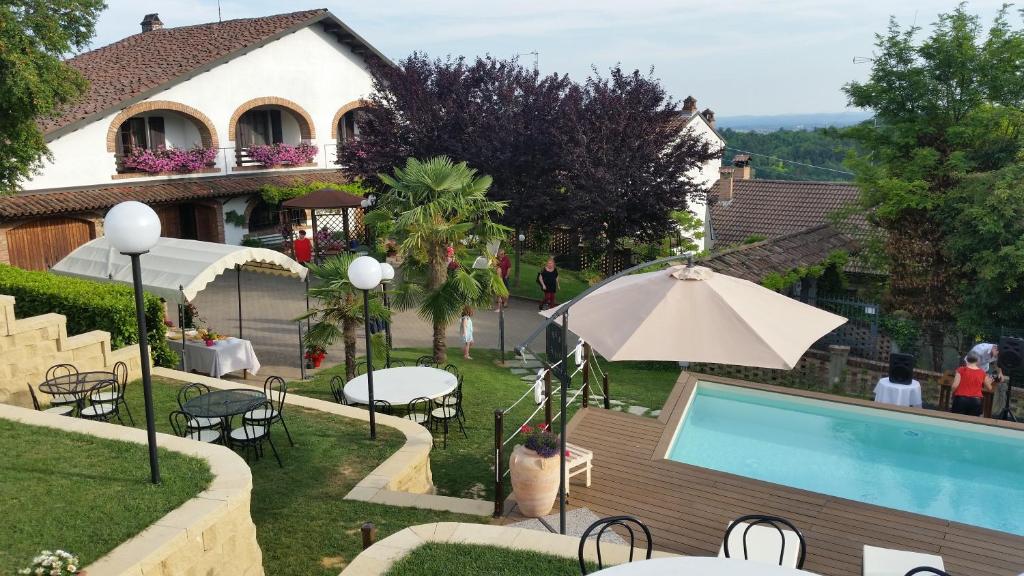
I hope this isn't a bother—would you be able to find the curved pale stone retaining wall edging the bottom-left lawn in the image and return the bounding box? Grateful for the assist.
[0,404,263,576]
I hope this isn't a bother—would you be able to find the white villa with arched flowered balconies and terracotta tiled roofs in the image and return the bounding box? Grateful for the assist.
[0,9,389,270]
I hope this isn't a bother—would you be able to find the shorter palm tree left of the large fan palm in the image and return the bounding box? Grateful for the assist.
[299,254,390,379]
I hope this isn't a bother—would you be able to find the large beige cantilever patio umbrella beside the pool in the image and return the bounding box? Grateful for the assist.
[542,265,846,369]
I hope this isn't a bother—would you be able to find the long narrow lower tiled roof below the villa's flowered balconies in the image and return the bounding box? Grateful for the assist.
[0,169,349,219]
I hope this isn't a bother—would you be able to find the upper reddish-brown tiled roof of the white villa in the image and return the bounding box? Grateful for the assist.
[40,8,390,140]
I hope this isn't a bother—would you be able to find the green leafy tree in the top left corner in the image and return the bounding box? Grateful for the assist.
[0,0,106,194]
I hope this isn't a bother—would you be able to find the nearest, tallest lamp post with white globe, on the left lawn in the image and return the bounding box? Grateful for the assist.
[103,201,160,484]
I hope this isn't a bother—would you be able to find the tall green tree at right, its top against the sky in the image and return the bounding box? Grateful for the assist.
[844,4,1024,349]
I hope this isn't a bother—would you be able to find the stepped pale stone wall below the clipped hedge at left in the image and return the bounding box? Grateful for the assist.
[0,294,141,408]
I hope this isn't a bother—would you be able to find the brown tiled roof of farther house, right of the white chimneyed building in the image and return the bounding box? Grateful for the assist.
[709,178,868,247]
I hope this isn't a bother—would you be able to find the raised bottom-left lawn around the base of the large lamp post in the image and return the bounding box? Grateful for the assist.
[0,414,213,574]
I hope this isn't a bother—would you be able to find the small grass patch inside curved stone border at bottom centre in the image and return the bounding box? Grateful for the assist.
[386,542,597,576]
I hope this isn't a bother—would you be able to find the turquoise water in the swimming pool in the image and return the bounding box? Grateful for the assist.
[667,382,1024,536]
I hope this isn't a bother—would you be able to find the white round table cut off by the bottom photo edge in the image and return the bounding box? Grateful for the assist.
[594,557,817,576]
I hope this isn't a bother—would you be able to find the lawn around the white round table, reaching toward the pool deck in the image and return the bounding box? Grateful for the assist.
[289,348,680,499]
